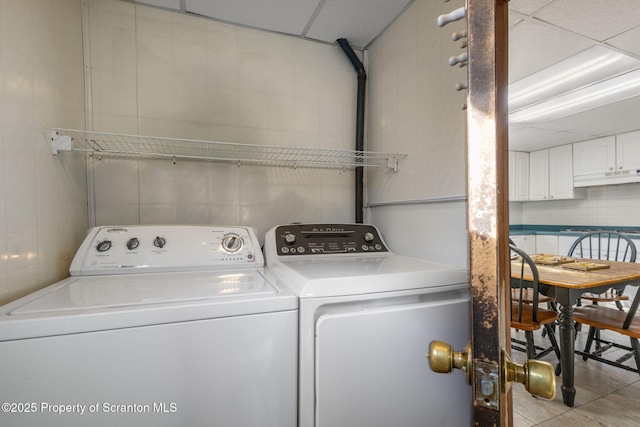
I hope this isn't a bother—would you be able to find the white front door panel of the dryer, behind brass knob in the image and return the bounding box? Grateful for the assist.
[315,291,471,427]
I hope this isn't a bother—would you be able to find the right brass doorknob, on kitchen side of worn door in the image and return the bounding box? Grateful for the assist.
[502,349,556,399]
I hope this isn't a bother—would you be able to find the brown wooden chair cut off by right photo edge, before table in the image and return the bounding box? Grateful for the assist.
[573,292,640,374]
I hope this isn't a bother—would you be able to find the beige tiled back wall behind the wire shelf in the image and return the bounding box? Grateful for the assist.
[89,0,356,241]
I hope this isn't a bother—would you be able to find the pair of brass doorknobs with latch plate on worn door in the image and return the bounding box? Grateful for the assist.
[427,341,556,399]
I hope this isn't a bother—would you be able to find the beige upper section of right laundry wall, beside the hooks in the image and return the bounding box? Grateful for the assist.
[368,1,467,202]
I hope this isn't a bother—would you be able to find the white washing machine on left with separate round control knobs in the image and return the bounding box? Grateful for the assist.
[0,226,298,427]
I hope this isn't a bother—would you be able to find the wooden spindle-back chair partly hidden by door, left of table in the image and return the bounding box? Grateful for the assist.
[509,245,561,375]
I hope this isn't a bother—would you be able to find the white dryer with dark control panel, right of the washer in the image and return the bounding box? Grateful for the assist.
[264,224,472,427]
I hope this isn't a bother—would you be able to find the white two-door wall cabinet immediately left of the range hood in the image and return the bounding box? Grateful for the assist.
[529,144,586,200]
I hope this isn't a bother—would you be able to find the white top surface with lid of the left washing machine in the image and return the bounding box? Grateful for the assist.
[0,269,297,341]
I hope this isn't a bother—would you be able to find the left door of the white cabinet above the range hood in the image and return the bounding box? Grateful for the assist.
[573,136,616,176]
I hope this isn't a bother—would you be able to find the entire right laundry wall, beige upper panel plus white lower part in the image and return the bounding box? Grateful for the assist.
[367,0,468,266]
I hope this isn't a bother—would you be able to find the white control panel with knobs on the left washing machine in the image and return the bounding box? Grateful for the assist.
[70,225,264,275]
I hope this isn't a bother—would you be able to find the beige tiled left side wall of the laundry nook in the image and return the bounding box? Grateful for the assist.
[0,0,87,304]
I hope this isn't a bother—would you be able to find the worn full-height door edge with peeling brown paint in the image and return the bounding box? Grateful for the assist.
[466,0,513,426]
